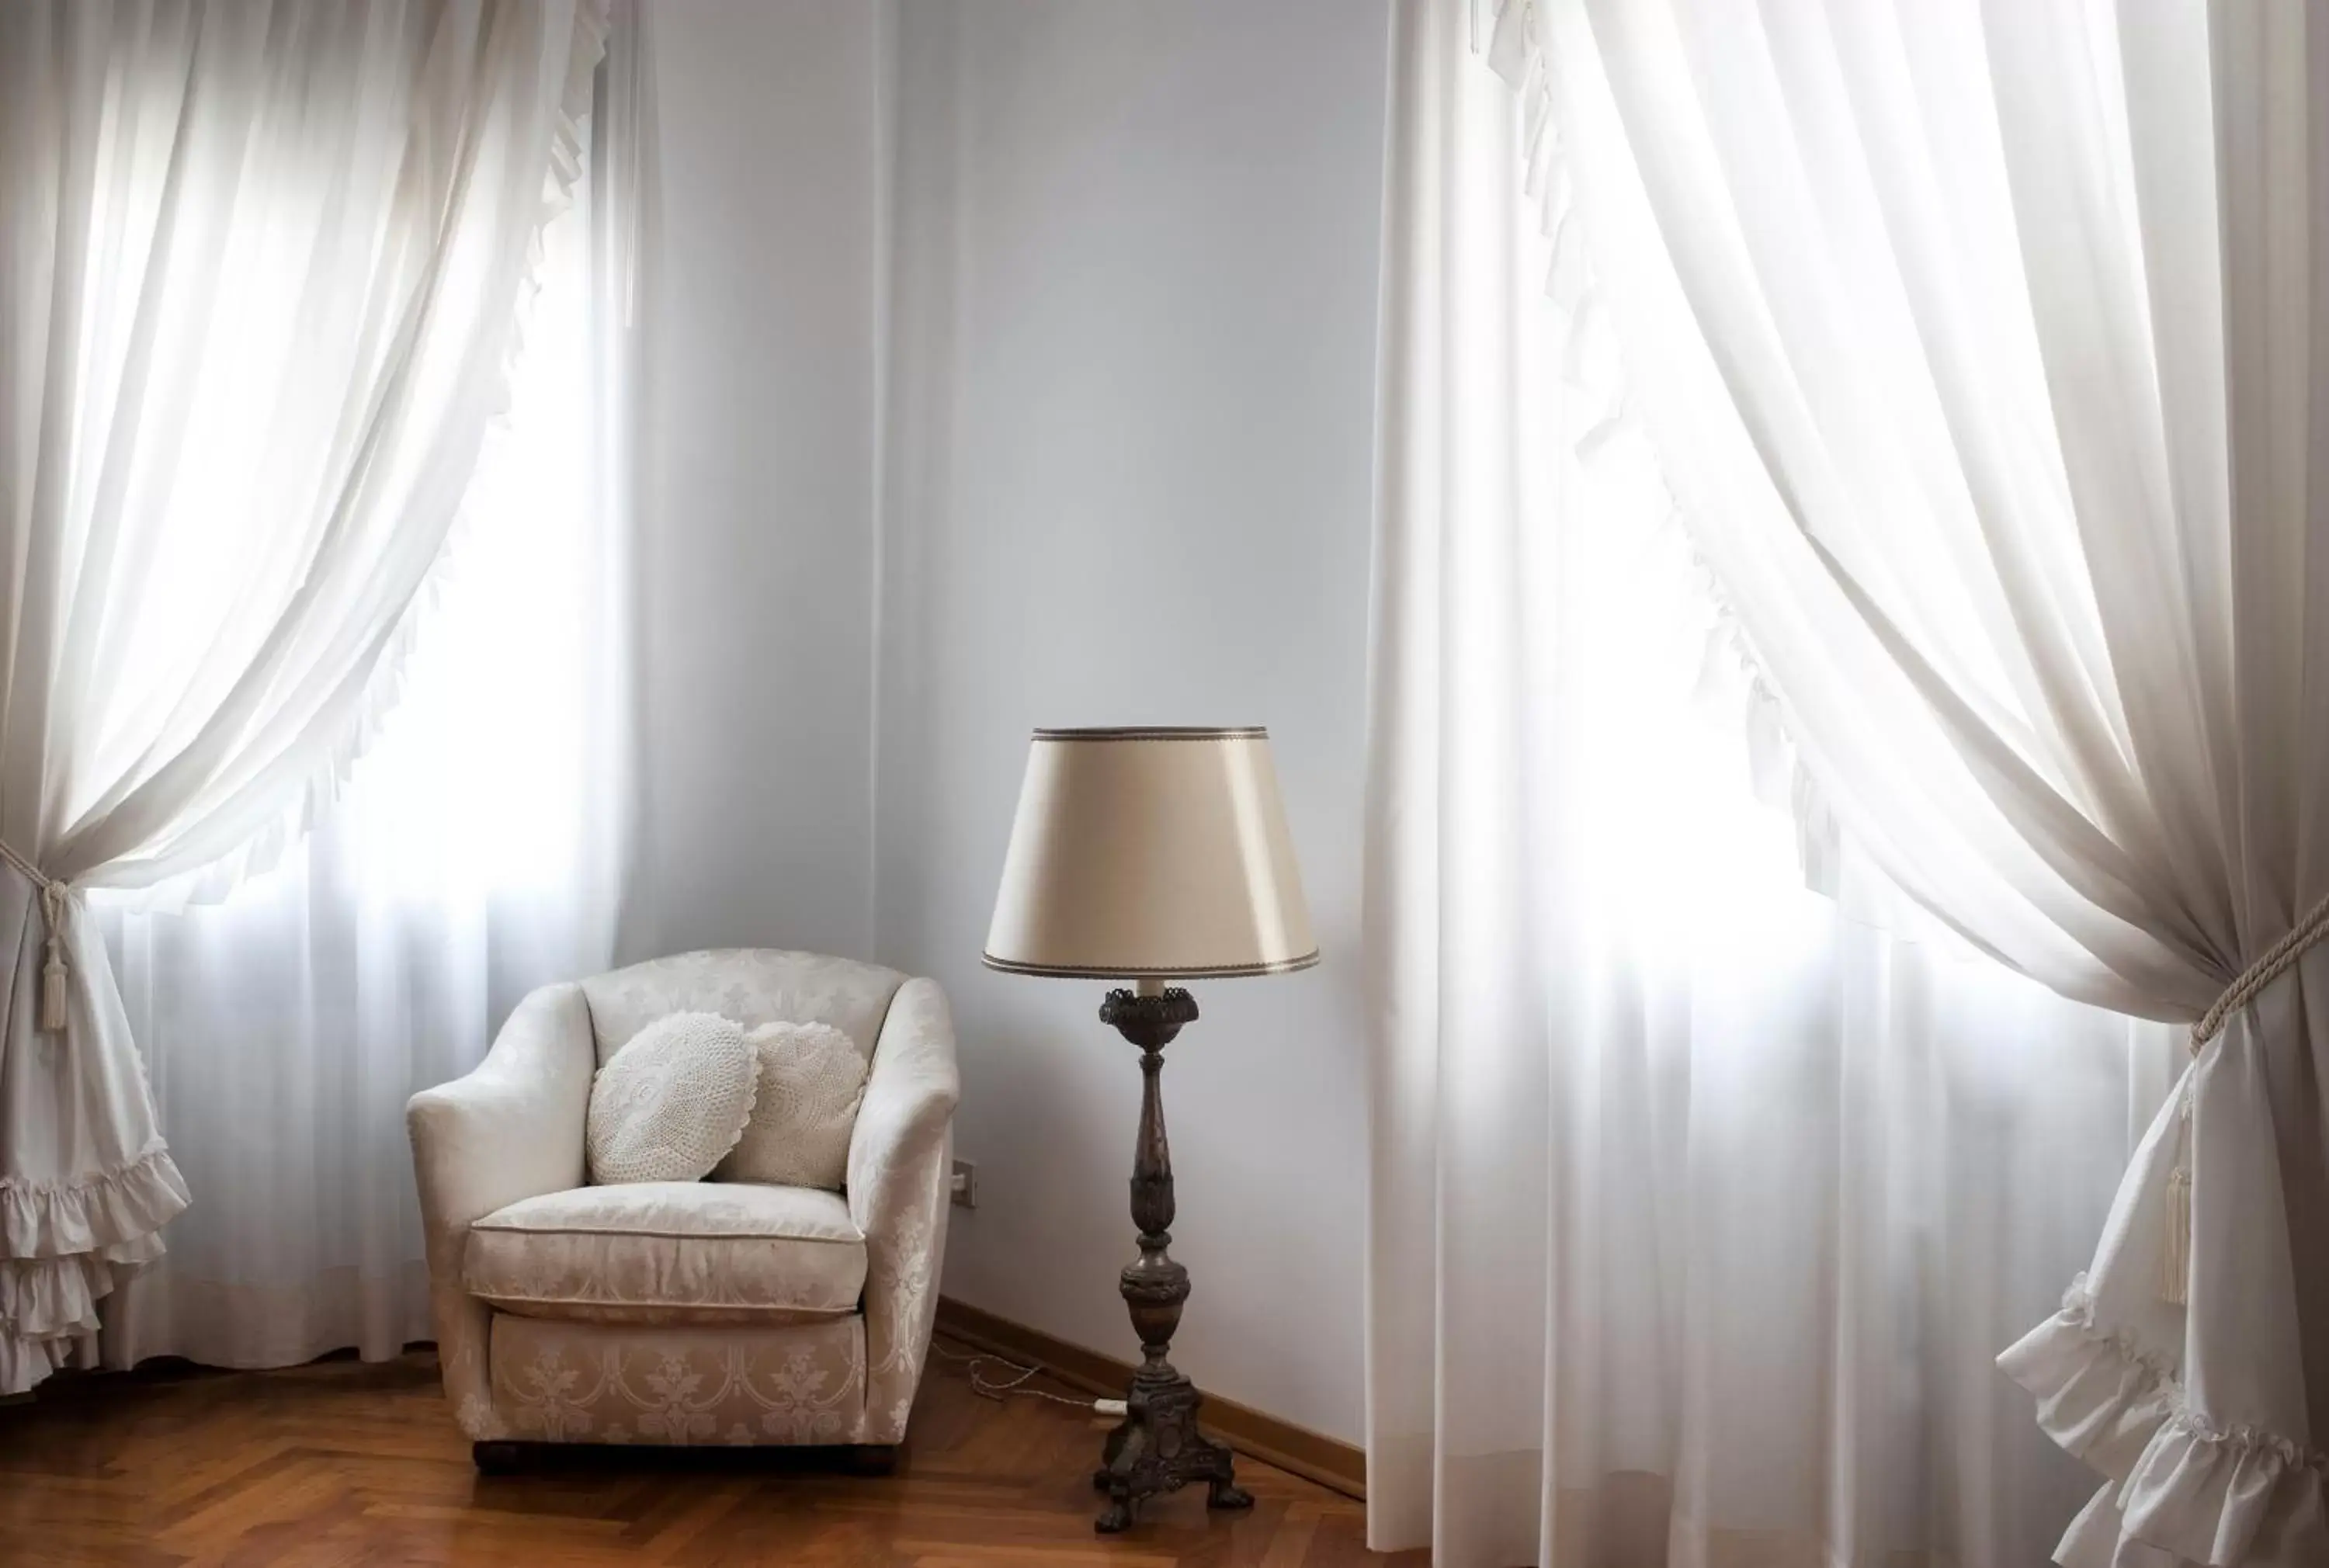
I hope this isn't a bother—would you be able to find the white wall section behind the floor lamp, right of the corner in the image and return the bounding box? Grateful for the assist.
[876,0,1388,1440]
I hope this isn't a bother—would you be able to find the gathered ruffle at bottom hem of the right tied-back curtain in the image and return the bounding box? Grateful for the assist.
[1998,1275,2329,1568]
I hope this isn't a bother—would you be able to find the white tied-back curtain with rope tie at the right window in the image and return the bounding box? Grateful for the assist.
[1453,0,2329,1568]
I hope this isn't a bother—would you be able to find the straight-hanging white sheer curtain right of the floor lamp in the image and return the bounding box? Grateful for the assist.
[1367,0,2182,1568]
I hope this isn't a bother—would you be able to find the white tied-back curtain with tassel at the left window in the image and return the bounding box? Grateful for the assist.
[0,0,603,1391]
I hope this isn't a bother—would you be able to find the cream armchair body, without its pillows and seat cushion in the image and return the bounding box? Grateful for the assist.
[408,951,960,1442]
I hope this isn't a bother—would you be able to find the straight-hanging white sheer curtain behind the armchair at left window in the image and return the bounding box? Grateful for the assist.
[91,5,638,1365]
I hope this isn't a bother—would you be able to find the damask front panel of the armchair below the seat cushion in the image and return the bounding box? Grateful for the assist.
[494,1314,866,1445]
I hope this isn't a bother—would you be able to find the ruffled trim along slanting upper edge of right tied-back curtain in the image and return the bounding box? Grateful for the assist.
[1472,0,1842,897]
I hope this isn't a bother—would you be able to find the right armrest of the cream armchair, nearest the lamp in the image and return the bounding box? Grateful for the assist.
[848,981,962,1442]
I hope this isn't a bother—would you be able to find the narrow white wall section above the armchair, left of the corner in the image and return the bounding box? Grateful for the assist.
[622,0,883,956]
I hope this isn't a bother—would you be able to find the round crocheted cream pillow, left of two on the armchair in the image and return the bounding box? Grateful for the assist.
[585,1014,759,1186]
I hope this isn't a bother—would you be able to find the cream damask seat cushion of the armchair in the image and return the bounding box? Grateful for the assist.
[461,1181,866,1326]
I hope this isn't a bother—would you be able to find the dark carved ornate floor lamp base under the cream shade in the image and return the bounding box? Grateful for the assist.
[1092,981,1253,1535]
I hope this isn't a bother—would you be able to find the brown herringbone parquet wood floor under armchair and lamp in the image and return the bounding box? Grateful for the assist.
[0,1354,1425,1568]
